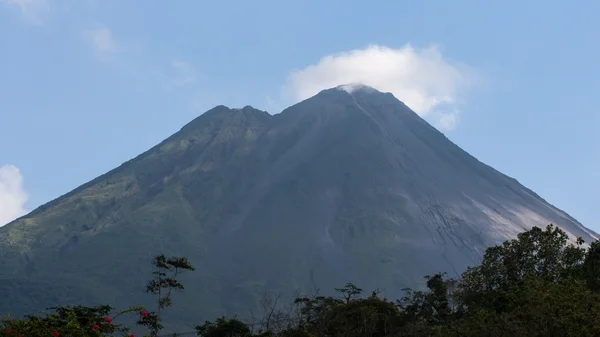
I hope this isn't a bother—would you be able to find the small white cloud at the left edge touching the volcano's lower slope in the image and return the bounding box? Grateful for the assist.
[0,165,27,226]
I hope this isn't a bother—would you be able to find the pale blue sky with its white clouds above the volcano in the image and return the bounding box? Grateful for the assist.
[0,0,600,231]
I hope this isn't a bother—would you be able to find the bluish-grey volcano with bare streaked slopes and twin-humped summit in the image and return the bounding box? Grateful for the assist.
[0,86,597,325]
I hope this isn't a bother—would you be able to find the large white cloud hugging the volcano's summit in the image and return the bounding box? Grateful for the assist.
[284,44,475,130]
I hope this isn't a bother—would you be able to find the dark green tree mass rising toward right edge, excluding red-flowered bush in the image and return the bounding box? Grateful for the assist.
[193,225,600,337]
